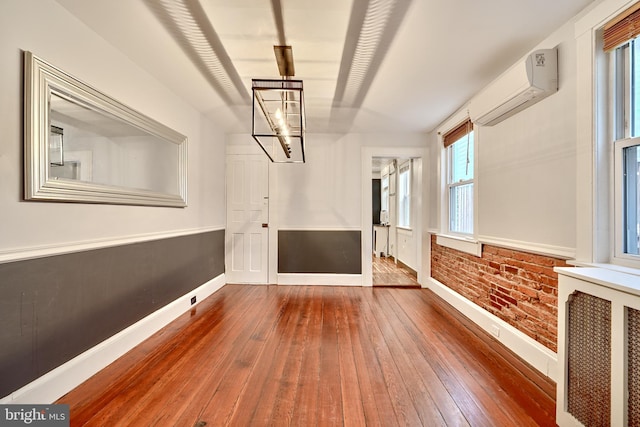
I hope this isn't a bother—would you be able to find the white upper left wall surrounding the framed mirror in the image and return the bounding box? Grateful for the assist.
[0,0,225,258]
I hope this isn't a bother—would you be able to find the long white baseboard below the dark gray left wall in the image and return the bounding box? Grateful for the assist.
[0,274,225,404]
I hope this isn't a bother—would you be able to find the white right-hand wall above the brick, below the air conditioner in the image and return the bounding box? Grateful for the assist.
[427,15,576,256]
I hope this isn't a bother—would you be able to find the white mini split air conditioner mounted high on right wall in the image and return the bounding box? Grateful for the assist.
[469,48,558,126]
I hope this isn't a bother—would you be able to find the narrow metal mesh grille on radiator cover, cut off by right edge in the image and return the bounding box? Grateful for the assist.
[627,308,640,426]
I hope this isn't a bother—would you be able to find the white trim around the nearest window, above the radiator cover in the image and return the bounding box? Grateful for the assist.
[574,0,640,271]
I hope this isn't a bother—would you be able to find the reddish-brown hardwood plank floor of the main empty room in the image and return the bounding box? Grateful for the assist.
[58,285,555,426]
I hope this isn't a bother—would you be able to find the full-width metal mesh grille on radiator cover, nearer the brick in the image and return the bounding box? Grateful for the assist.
[567,292,611,426]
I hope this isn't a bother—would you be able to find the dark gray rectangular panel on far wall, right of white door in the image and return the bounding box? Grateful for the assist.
[278,230,362,274]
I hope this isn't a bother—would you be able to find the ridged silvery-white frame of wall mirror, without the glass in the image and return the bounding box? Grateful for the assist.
[24,52,187,207]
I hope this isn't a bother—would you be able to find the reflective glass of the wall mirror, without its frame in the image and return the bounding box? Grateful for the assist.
[49,93,179,194]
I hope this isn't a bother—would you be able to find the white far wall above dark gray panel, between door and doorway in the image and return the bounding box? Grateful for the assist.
[227,133,425,230]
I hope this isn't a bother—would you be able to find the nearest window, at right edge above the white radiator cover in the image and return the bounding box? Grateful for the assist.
[604,18,640,263]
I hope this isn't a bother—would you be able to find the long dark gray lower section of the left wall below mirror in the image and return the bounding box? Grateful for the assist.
[0,230,224,397]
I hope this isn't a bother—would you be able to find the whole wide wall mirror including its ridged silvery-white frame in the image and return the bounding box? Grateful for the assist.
[24,52,187,207]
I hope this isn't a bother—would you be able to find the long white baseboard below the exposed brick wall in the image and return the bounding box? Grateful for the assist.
[427,277,558,383]
